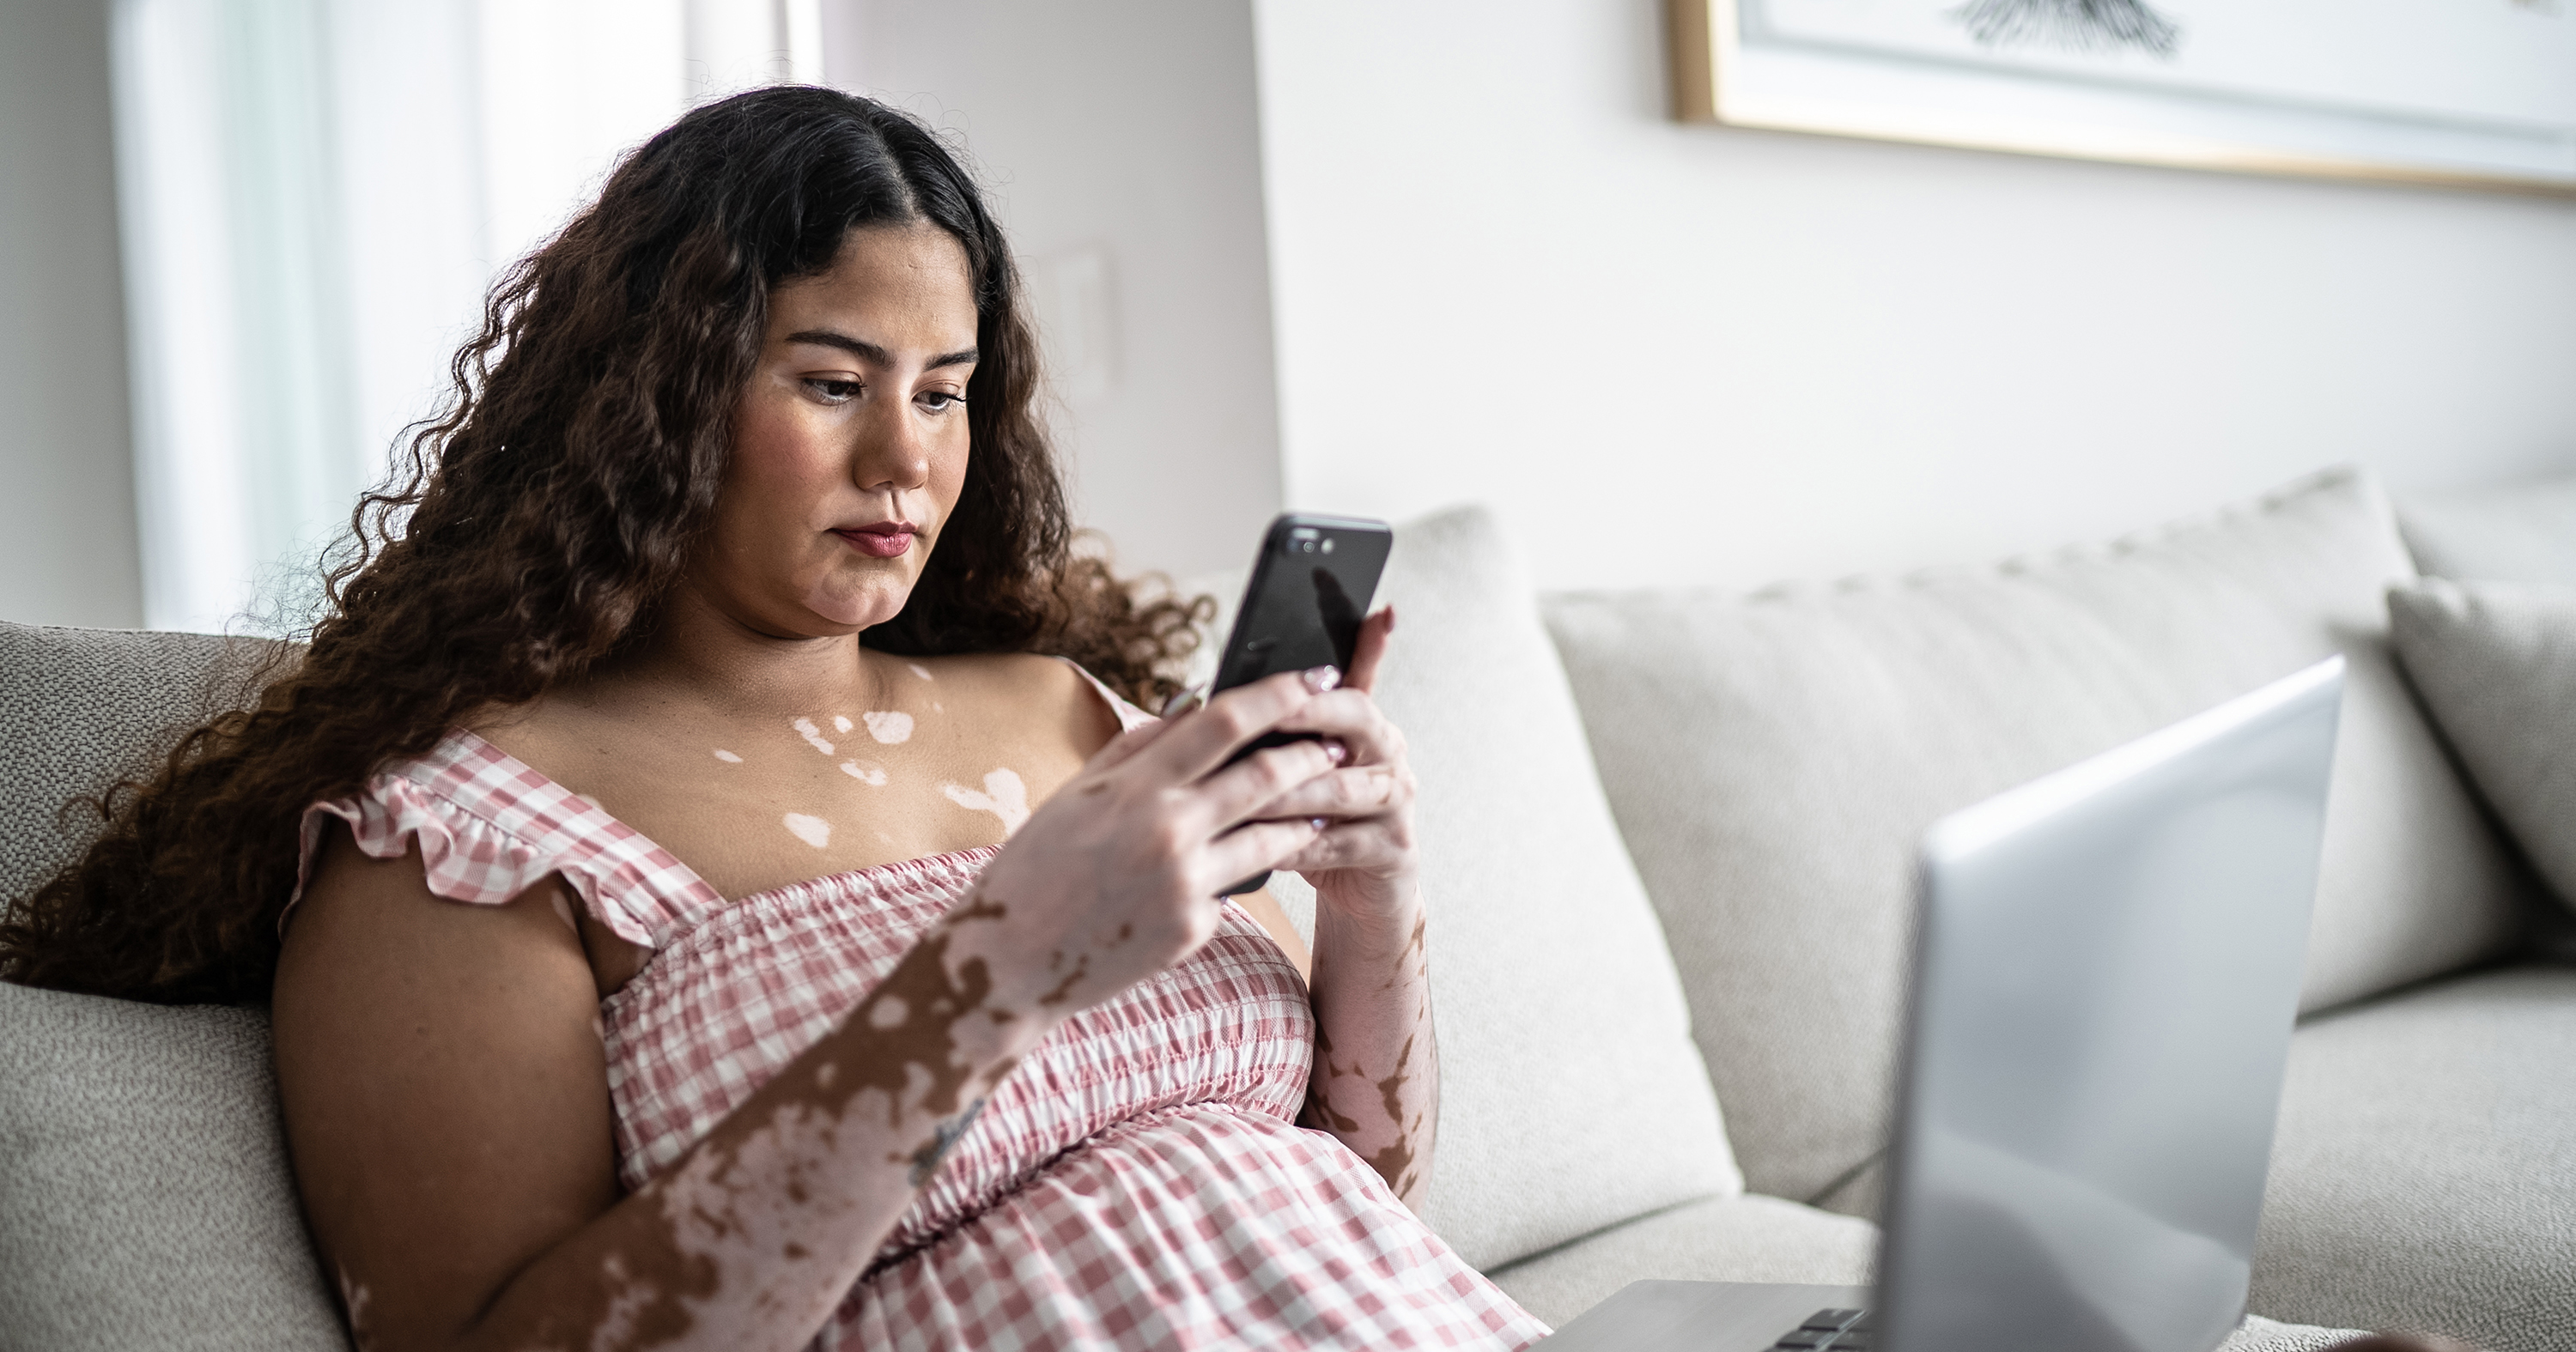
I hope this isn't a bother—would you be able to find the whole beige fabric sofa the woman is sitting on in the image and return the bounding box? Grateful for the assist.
[0,461,2576,1352]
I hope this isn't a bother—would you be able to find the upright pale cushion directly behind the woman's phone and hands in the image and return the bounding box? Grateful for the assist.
[1298,510,1741,1267]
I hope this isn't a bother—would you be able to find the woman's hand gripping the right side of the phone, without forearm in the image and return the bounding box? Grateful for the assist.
[1255,608,1422,919]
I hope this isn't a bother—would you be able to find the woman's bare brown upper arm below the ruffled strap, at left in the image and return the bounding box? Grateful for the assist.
[270,832,618,1329]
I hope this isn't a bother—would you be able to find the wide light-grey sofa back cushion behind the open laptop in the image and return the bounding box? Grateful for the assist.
[1548,471,2519,1200]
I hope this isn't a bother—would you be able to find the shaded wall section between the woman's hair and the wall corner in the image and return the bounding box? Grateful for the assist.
[822,0,1280,574]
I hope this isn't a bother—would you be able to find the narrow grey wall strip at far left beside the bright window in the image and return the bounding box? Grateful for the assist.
[0,0,142,626]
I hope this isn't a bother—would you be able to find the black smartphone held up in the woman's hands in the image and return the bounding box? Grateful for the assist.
[1208,512,1396,896]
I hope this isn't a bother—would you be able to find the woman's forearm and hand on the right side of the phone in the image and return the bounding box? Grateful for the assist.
[1260,608,1440,1210]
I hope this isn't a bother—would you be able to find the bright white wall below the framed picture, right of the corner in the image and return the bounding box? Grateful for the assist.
[1255,0,2576,585]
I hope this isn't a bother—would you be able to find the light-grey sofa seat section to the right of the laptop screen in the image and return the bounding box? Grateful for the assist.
[2251,968,2576,1352]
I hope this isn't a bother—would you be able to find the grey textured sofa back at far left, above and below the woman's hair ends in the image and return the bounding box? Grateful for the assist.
[0,623,348,1349]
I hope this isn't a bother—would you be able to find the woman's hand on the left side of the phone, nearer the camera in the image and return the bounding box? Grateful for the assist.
[948,667,1365,1020]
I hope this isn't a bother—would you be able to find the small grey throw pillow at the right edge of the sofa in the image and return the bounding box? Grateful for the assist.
[2388,577,2576,906]
